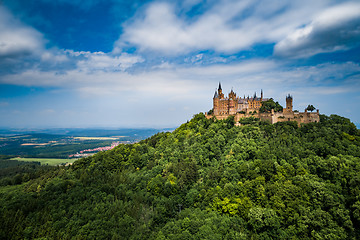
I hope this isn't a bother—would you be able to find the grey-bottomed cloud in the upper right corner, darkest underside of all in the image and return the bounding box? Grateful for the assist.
[274,3,360,58]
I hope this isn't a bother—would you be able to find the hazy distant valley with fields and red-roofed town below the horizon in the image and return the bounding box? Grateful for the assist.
[0,128,171,159]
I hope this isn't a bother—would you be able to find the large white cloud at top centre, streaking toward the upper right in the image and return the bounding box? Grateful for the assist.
[115,0,326,55]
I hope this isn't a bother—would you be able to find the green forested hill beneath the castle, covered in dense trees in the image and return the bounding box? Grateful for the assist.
[0,114,360,239]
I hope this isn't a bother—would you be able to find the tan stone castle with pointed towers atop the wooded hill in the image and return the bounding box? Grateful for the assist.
[206,83,320,126]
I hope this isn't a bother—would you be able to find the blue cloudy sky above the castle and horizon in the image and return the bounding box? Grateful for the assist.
[0,0,360,128]
